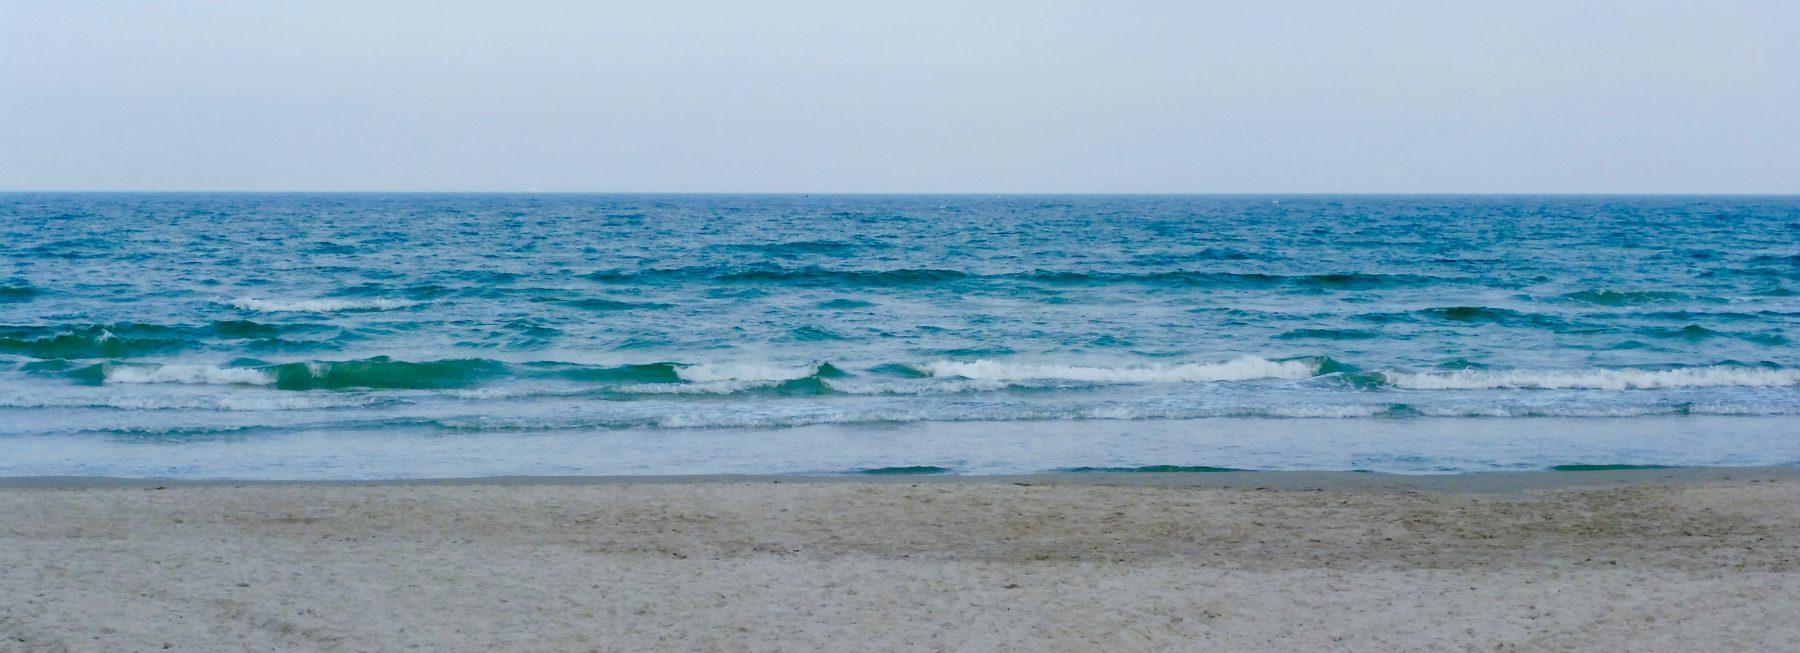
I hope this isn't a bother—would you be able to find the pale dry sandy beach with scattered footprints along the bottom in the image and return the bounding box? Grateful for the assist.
[0,470,1800,651]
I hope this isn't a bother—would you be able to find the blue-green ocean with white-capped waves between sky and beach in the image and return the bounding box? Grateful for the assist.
[0,192,1800,479]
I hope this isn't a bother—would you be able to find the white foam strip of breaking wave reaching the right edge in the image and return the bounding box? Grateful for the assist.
[1382,365,1800,390]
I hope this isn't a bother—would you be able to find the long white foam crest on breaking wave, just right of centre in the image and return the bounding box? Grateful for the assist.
[920,356,1319,383]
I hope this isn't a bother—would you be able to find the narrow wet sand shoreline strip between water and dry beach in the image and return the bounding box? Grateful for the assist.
[0,466,1800,495]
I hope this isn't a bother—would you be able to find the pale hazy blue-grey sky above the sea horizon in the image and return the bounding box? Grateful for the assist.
[0,0,1800,192]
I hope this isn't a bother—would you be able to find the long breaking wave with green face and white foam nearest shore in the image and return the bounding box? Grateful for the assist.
[63,356,1800,399]
